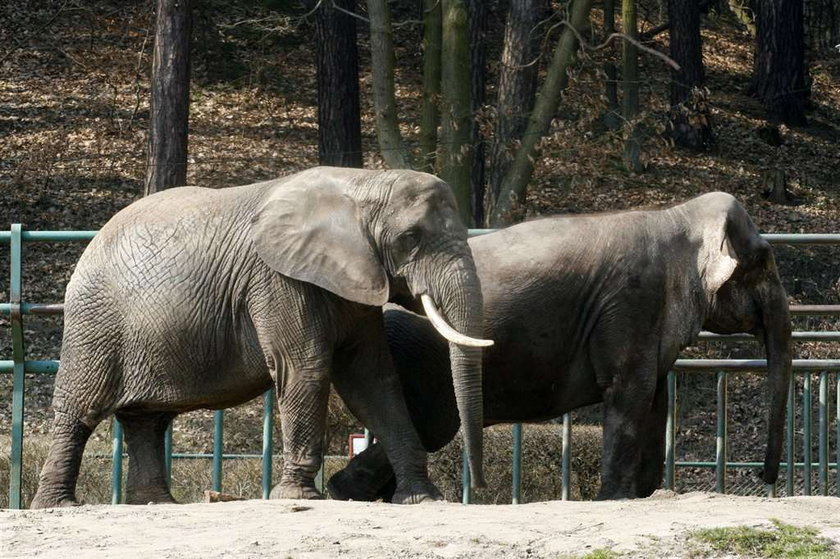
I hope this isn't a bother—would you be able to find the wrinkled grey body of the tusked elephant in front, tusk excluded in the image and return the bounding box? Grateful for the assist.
[32,167,482,508]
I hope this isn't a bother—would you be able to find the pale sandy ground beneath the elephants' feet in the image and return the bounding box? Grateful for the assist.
[0,493,840,559]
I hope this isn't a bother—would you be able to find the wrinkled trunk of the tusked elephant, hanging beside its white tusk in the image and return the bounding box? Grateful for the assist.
[433,259,485,487]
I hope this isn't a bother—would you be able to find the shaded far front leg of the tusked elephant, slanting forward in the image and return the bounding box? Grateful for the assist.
[333,316,443,504]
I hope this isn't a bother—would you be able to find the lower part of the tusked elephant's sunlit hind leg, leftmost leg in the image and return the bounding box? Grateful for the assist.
[30,412,95,509]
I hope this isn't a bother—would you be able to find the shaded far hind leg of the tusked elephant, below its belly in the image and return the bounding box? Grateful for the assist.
[117,413,175,505]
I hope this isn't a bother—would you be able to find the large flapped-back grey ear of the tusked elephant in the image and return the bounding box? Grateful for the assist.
[251,181,388,306]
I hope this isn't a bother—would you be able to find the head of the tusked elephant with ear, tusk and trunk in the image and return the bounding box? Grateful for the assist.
[252,167,492,487]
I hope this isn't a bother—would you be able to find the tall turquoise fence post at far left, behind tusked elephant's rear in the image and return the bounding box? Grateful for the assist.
[9,223,26,509]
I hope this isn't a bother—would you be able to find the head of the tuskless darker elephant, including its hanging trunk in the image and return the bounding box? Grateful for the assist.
[694,192,791,483]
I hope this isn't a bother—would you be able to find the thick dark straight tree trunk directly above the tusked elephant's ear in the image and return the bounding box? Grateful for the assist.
[310,0,362,167]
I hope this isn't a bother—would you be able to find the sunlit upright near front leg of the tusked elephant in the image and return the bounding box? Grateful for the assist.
[271,360,330,499]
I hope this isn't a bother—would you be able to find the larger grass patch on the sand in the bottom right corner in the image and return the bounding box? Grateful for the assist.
[690,519,840,558]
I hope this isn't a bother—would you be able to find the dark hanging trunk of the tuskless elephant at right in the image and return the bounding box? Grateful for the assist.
[759,277,791,484]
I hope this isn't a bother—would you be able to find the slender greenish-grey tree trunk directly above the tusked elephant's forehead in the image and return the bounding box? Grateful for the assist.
[367,0,411,169]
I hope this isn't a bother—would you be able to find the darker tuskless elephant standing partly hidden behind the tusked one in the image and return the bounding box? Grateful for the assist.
[328,193,791,500]
